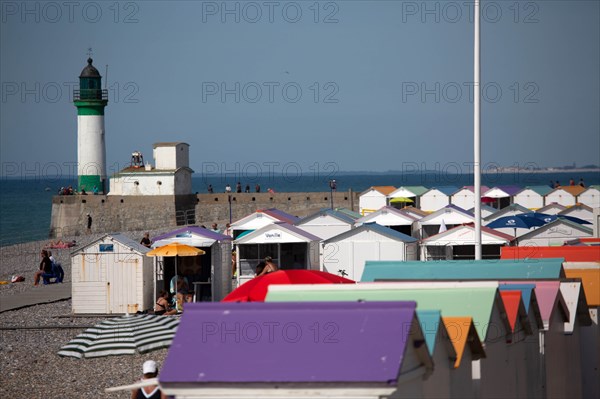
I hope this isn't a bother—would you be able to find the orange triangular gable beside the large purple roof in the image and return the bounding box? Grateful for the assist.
[442,316,486,369]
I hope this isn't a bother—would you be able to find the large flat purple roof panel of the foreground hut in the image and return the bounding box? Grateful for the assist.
[159,301,424,389]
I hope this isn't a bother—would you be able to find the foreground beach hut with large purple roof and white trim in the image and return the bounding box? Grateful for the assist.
[159,302,433,399]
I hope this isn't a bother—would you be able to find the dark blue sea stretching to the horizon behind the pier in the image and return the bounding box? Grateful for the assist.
[0,171,600,247]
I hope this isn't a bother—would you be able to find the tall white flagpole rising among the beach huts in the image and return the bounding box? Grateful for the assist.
[473,0,481,260]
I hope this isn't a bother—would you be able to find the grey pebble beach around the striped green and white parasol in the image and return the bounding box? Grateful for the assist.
[0,232,168,399]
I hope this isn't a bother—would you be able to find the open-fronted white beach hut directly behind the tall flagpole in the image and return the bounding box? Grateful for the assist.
[420,224,513,260]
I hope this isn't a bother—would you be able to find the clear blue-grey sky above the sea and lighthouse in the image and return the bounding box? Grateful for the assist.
[0,0,600,176]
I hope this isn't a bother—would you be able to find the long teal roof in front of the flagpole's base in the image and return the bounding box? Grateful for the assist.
[361,258,564,282]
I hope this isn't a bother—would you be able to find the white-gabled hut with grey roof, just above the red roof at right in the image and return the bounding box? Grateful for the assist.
[516,218,593,247]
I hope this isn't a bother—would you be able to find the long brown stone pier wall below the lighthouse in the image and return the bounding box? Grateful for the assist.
[50,190,358,238]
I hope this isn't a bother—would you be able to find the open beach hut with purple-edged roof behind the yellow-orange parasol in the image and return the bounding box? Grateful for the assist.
[152,226,233,301]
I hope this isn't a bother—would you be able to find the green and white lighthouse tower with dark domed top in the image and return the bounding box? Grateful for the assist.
[73,58,108,193]
